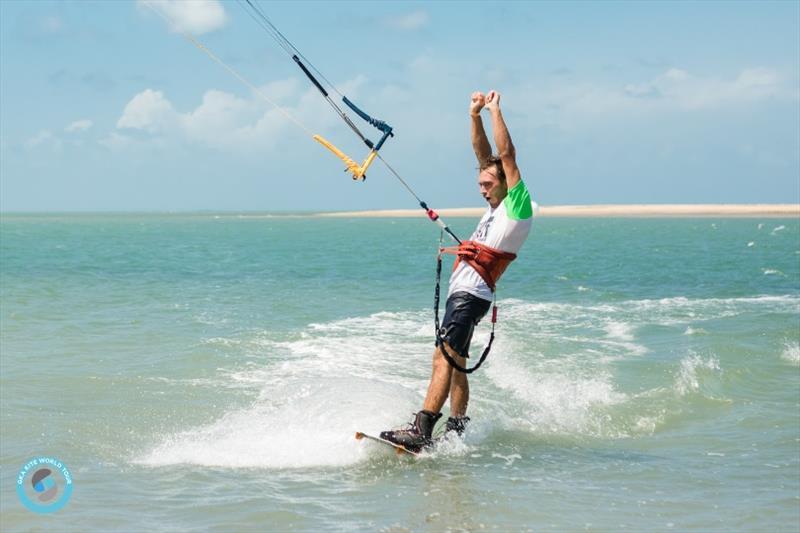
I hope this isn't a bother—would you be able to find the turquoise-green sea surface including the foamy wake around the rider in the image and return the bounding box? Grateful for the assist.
[0,214,800,531]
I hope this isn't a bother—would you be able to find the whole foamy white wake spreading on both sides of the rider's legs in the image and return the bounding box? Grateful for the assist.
[135,295,800,469]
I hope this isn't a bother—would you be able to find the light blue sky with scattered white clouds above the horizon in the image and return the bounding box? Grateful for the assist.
[0,0,800,212]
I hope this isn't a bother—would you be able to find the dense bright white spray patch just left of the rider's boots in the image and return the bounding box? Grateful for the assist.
[135,379,415,468]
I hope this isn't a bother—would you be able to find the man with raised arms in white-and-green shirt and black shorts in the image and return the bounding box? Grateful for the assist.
[380,91,533,452]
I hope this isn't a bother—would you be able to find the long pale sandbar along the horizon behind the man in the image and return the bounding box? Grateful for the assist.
[312,204,800,218]
